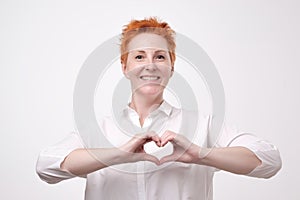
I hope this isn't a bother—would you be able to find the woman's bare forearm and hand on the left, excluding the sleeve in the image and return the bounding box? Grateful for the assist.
[61,132,160,176]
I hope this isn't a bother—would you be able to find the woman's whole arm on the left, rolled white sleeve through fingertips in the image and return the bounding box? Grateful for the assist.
[36,130,160,184]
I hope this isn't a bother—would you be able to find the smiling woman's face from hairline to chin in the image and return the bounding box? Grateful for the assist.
[122,33,172,95]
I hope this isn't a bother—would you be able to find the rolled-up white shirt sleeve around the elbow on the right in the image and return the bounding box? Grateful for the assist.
[217,126,282,178]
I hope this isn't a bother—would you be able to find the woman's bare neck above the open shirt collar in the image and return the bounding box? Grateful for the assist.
[129,93,163,125]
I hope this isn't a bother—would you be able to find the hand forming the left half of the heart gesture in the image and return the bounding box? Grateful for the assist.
[120,132,161,165]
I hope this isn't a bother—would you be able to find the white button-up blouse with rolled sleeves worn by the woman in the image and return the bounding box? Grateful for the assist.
[36,101,281,200]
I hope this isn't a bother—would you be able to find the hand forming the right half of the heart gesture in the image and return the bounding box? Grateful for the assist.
[160,131,200,164]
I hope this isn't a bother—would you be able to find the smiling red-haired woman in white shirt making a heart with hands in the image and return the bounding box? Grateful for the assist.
[37,18,281,200]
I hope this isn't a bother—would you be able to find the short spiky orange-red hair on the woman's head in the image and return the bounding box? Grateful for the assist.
[121,17,176,68]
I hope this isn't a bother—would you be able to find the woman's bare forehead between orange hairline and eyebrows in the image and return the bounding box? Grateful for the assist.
[127,33,168,51]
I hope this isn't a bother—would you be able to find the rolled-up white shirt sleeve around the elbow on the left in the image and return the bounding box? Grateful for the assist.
[36,132,84,184]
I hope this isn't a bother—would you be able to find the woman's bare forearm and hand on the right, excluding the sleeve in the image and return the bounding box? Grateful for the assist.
[161,131,280,177]
